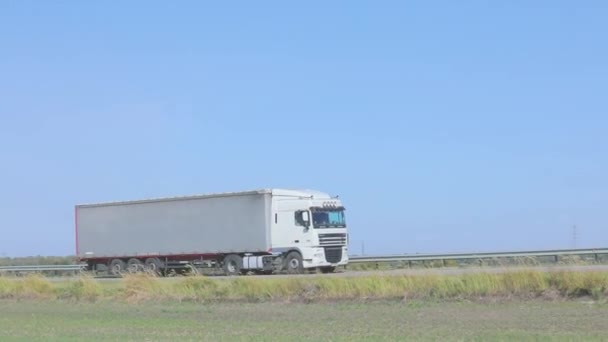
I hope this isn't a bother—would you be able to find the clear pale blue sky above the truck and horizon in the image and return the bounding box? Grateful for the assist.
[0,0,608,256]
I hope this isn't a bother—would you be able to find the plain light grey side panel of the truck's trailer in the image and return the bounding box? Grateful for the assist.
[76,193,271,258]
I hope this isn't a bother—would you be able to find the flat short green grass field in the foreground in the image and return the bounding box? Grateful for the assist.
[0,300,608,341]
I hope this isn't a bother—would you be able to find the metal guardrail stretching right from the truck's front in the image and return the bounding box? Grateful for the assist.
[349,248,608,263]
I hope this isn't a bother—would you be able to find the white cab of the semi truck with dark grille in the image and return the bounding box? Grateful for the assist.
[270,189,348,273]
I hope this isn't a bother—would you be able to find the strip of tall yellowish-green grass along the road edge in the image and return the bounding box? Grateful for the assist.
[0,271,608,303]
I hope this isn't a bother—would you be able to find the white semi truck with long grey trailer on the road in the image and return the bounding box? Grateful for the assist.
[75,189,348,275]
